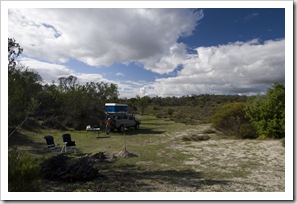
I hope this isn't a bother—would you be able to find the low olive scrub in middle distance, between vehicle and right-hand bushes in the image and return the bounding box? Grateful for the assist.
[134,94,247,124]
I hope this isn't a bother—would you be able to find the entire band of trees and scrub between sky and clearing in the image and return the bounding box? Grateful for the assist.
[8,39,285,138]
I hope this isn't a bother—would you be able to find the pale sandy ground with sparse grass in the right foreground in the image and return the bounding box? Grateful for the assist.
[164,125,285,192]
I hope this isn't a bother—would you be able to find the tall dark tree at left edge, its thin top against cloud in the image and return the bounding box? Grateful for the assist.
[8,38,42,135]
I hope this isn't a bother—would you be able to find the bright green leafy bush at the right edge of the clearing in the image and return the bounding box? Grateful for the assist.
[246,83,285,138]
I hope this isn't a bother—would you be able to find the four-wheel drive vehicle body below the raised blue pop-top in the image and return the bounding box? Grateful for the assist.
[107,113,140,132]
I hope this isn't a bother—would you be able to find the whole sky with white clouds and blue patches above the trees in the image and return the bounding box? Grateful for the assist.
[8,8,285,98]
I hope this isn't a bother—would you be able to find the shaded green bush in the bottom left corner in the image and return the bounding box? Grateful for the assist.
[8,149,40,192]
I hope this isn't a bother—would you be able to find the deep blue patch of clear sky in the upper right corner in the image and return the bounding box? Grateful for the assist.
[180,8,285,47]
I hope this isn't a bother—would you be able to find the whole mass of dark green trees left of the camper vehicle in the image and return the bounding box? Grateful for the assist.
[8,38,119,132]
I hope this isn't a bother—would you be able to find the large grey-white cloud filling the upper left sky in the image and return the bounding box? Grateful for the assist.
[8,9,203,74]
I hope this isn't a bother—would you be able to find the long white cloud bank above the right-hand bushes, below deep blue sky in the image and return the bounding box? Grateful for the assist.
[142,39,285,96]
